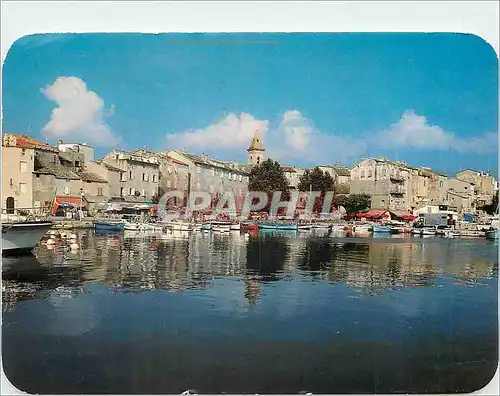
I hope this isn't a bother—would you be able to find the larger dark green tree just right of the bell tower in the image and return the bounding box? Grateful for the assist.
[248,158,290,211]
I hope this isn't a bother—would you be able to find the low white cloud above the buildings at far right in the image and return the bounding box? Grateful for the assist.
[375,110,497,153]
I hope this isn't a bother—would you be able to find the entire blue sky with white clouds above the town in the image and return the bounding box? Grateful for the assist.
[3,33,498,173]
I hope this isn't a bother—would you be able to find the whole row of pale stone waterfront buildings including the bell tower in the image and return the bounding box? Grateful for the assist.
[2,133,498,217]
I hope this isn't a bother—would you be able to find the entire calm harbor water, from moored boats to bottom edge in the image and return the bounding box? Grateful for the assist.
[2,231,498,394]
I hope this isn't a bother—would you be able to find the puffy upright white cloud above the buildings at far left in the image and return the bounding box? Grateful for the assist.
[41,77,120,147]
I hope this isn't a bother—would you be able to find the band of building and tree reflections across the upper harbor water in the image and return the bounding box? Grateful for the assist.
[3,231,498,309]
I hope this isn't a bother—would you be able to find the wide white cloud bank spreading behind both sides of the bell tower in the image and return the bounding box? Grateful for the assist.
[166,110,365,164]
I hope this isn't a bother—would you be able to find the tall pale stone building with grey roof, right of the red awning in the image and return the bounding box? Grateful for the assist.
[100,150,159,203]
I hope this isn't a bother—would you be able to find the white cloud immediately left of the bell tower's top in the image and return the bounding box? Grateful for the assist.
[166,113,269,151]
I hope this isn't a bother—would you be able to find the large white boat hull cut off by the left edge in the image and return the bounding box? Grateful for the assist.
[2,220,52,255]
